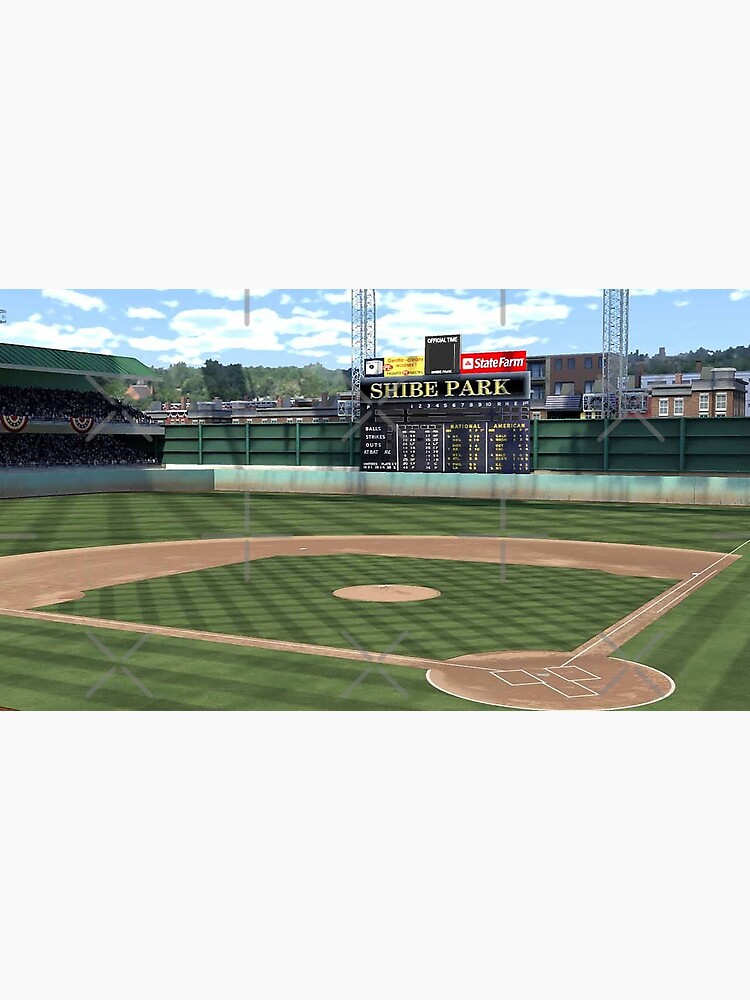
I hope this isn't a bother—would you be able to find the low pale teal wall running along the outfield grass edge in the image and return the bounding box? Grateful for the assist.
[0,465,750,506]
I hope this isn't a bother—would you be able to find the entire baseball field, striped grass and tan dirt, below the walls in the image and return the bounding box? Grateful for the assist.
[0,493,750,711]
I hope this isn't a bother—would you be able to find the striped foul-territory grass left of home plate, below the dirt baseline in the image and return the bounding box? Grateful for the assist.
[0,618,493,711]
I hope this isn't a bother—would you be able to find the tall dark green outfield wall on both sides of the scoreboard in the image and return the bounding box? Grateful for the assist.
[163,417,750,475]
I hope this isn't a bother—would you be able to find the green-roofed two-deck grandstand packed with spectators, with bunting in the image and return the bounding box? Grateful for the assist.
[0,344,164,469]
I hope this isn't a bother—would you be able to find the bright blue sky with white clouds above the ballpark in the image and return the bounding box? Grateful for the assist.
[0,288,750,368]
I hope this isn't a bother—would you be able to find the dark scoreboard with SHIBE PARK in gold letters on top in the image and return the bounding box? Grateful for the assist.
[360,373,531,474]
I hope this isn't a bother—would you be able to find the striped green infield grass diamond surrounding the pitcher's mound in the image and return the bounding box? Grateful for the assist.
[44,554,674,660]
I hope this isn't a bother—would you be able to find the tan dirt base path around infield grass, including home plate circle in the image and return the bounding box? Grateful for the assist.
[0,535,740,709]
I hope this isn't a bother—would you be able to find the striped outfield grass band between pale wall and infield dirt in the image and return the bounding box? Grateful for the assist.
[0,493,750,555]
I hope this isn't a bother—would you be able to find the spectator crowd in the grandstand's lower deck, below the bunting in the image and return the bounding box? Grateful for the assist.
[0,433,158,468]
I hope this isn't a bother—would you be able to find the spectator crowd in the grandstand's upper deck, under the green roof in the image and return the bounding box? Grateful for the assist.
[0,385,153,424]
